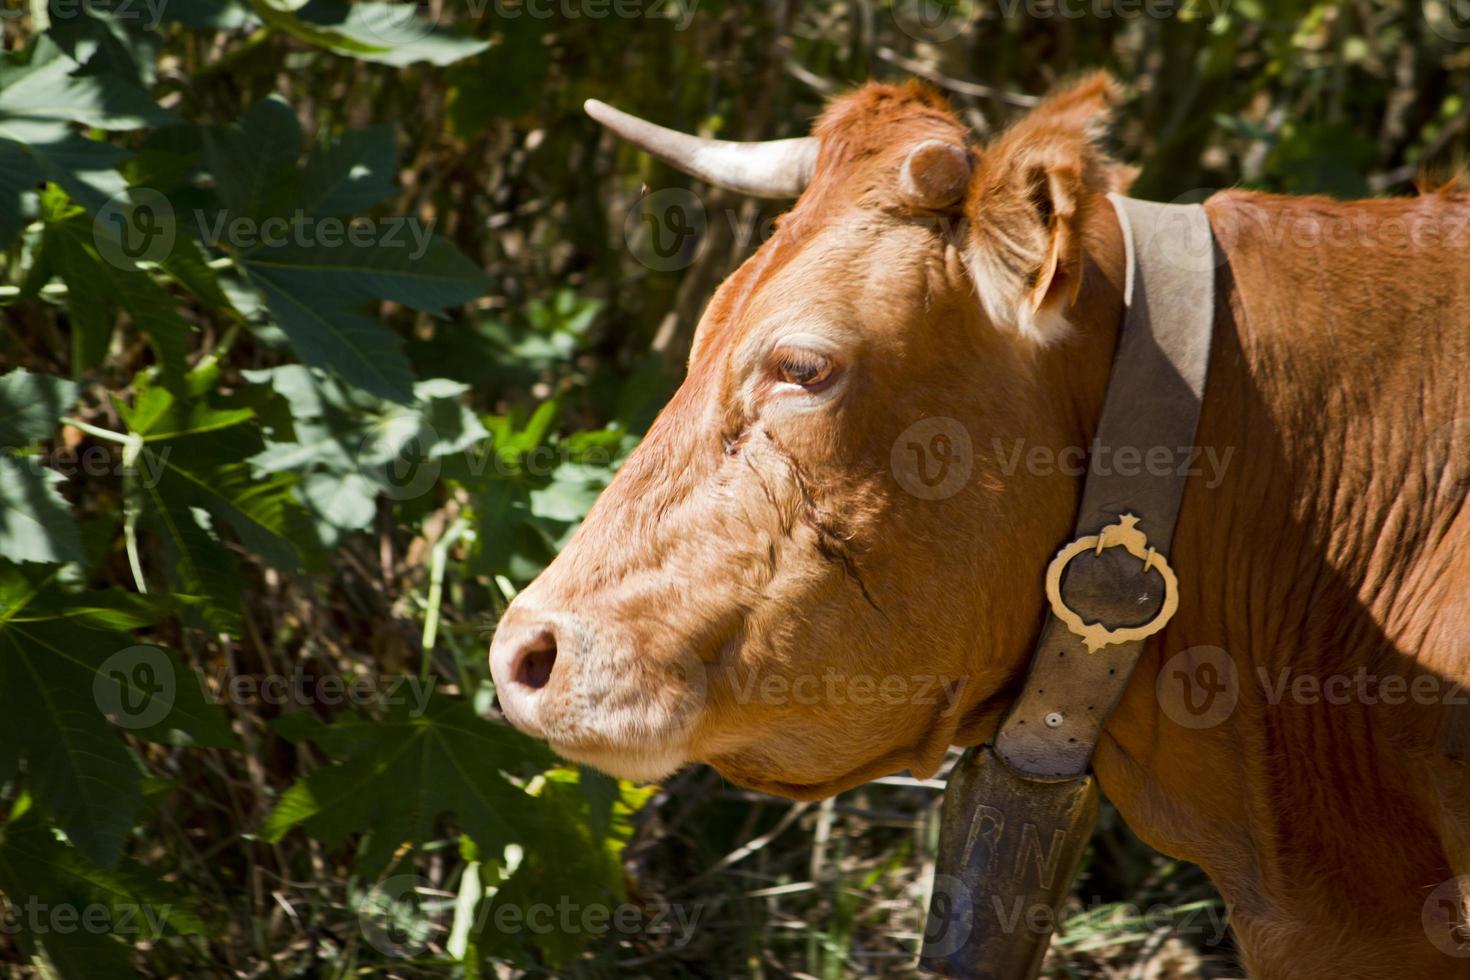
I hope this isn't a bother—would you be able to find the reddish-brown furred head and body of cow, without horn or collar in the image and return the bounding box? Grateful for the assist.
[491,76,1470,980]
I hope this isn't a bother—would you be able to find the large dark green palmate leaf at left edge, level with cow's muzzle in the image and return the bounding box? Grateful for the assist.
[0,563,234,865]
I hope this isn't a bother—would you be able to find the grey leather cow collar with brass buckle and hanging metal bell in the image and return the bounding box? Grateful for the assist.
[920,195,1223,980]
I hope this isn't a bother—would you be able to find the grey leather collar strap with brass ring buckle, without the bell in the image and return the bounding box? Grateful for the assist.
[995,194,1222,777]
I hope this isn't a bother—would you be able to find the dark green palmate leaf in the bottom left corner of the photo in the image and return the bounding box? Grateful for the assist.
[0,810,204,980]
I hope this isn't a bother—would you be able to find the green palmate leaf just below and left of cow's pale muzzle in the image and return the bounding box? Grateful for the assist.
[262,695,553,874]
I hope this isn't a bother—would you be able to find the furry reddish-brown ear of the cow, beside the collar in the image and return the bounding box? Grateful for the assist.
[966,73,1132,344]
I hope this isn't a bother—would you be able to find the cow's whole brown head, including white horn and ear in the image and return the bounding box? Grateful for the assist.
[491,76,1126,798]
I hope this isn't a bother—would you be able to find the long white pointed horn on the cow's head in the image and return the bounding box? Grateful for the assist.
[584,98,817,197]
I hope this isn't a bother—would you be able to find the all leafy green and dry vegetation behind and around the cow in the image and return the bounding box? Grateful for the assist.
[0,0,1470,979]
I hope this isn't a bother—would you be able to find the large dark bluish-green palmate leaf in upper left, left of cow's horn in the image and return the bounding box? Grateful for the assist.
[200,98,485,403]
